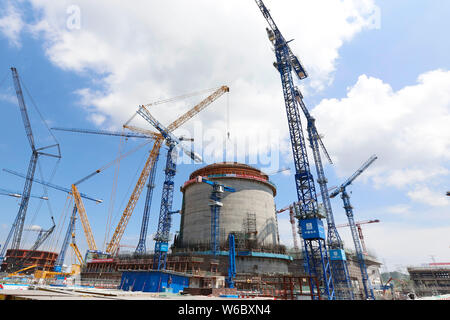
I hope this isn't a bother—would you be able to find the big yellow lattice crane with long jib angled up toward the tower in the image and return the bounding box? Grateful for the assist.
[106,86,230,254]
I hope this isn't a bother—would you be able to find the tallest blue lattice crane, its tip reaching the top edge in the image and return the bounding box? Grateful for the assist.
[255,0,335,300]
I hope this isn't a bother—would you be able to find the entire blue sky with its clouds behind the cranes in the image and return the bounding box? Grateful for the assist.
[0,0,450,269]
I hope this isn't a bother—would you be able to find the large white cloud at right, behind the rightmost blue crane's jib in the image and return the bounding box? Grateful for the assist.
[312,70,450,198]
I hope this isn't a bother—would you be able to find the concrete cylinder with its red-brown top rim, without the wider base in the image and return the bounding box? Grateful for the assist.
[179,162,279,248]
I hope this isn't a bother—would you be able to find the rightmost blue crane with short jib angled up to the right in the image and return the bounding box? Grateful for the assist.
[330,155,377,300]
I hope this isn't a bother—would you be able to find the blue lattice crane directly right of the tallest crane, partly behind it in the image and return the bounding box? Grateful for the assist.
[295,88,354,300]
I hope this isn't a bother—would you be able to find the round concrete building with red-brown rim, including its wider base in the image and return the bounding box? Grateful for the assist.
[172,162,292,273]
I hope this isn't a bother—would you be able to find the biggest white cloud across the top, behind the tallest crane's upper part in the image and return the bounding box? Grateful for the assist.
[15,0,377,162]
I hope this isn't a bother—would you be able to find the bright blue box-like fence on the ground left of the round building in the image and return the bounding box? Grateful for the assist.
[119,271,189,293]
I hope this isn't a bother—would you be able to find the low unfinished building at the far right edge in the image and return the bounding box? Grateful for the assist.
[407,262,450,297]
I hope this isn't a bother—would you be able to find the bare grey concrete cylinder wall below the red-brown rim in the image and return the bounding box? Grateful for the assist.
[180,178,278,245]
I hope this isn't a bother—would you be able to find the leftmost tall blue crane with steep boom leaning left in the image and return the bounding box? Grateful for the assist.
[0,67,61,263]
